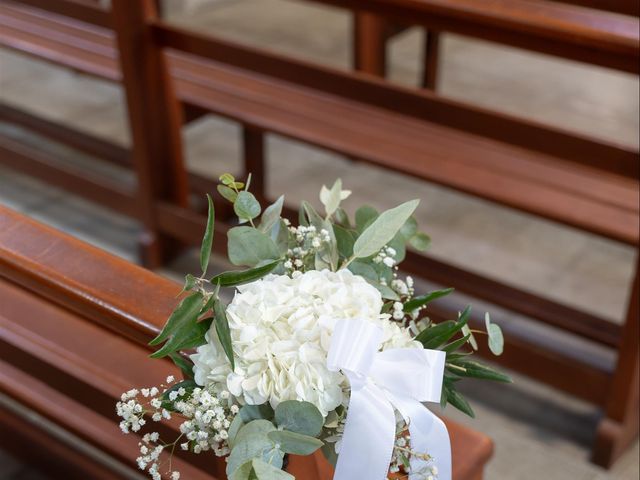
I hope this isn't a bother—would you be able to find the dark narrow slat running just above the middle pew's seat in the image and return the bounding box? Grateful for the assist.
[152,21,640,178]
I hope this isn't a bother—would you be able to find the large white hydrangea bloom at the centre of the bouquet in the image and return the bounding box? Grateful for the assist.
[191,269,422,416]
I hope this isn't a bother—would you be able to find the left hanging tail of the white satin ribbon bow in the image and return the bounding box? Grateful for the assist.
[333,374,396,480]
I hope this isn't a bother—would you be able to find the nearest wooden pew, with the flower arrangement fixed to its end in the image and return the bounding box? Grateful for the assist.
[0,207,492,480]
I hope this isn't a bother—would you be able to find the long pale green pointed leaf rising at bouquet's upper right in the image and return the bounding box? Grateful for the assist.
[353,200,420,258]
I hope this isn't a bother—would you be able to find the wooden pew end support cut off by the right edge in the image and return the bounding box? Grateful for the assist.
[591,260,640,468]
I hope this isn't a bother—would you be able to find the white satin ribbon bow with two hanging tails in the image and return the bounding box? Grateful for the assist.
[327,319,451,480]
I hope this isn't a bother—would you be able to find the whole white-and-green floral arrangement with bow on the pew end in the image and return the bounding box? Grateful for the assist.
[117,174,511,480]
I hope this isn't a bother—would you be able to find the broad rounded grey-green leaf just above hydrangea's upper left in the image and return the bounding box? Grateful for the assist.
[227,227,280,267]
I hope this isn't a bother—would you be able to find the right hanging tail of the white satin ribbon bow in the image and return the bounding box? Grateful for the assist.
[391,395,452,480]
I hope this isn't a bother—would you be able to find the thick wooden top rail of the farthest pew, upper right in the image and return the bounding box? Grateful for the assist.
[312,0,640,74]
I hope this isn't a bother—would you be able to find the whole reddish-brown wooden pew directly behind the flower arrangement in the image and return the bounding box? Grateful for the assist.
[0,0,639,464]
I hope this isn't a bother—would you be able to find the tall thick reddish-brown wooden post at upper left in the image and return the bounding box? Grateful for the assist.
[112,0,188,268]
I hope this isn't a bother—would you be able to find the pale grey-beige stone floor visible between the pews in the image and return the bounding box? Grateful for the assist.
[0,0,639,480]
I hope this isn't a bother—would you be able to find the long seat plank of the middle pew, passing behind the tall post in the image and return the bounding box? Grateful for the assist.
[0,0,638,244]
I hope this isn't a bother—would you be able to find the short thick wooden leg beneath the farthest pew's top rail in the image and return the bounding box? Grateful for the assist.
[353,11,388,77]
